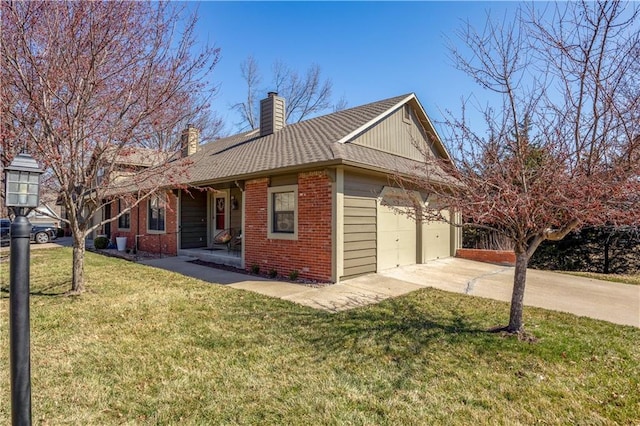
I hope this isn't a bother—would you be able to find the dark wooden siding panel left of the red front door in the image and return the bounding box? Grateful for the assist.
[180,189,208,249]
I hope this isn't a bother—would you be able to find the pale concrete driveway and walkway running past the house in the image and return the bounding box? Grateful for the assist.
[140,256,640,327]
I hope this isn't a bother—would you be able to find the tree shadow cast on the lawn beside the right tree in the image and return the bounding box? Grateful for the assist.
[285,290,524,359]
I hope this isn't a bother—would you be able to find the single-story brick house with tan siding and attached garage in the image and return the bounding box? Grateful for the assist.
[114,93,461,282]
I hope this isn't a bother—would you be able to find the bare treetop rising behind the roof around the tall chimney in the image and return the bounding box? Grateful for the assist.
[233,56,346,129]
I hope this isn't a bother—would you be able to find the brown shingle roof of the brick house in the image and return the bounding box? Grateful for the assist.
[156,94,456,185]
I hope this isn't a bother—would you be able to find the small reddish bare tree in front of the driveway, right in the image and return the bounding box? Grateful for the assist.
[404,2,640,332]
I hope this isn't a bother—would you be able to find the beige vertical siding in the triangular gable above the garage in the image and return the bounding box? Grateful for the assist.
[349,106,434,161]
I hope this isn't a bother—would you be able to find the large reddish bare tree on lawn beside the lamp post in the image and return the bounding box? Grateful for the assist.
[0,1,218,293]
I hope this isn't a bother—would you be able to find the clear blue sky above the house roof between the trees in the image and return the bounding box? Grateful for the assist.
[189,1,517,133]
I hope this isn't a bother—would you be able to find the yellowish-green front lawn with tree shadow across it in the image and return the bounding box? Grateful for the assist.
[0,249,640,425]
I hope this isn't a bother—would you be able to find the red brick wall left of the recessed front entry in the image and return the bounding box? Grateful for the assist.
[112,192,178,256]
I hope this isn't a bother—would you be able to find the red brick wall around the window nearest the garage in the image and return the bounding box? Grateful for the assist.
[243,171,332,281]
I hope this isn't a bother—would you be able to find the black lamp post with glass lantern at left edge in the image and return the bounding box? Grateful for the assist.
[4,153,42,425]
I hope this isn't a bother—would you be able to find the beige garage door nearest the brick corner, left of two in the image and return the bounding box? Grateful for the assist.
[377,189,417,271]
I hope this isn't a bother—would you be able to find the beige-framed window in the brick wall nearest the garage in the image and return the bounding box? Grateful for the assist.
[268,185,298,240]
